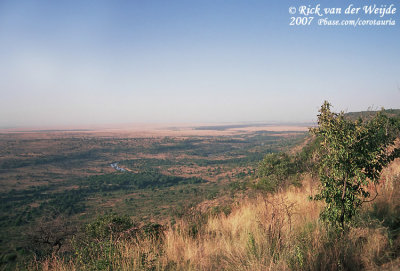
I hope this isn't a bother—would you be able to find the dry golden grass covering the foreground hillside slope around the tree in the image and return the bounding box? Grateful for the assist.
[29,161,400,271]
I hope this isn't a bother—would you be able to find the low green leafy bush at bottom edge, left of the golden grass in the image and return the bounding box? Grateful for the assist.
[73,216,165,270]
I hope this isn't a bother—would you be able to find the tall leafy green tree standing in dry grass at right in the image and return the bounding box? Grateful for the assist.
[311,101,400,230]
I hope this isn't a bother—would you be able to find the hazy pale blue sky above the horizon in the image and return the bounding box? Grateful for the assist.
[0,0,400,127]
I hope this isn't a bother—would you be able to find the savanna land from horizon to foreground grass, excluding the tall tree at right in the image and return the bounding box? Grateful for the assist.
[0,107,400,270]
